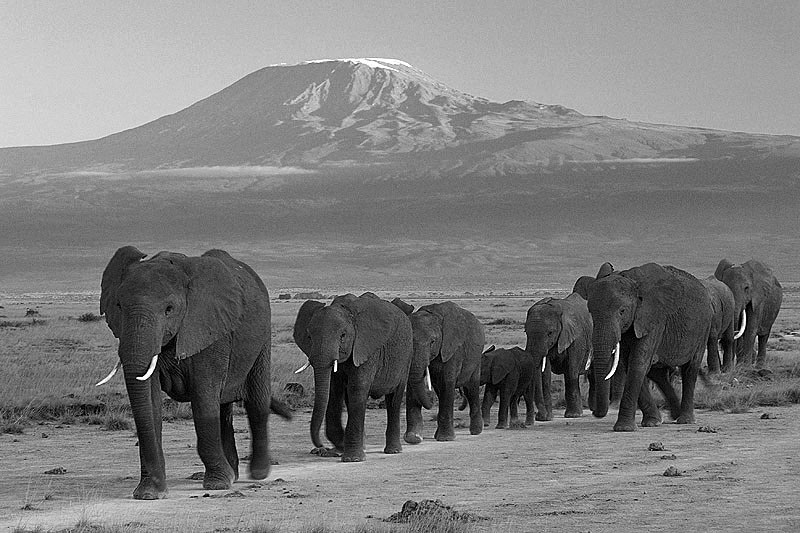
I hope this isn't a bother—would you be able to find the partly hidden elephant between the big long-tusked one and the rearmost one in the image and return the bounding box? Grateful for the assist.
[700,276,744,373]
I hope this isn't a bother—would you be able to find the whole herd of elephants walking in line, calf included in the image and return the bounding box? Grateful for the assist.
[98,246,782,499]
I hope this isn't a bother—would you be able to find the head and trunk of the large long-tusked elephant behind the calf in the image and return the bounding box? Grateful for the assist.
[587,263,692,418]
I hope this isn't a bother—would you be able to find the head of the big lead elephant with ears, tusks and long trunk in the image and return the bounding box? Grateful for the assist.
[100,246,243,497]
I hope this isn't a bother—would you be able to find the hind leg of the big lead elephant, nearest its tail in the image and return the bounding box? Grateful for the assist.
[242,345,272,479]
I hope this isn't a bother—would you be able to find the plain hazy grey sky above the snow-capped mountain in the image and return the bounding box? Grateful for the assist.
[0,0,800,146]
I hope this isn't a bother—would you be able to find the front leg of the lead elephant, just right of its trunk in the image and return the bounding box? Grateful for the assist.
[192,391,236,490]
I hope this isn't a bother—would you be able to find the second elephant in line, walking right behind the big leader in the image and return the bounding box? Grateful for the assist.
[293,293,431,462]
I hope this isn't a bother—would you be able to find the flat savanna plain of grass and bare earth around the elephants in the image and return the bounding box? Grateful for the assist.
[0,283,800,533]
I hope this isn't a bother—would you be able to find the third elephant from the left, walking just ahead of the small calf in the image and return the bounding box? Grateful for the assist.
[396,301,485,444]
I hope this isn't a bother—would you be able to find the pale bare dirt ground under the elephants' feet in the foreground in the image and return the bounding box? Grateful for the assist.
[0,405,800,531]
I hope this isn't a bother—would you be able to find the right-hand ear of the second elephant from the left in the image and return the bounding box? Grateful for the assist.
[350,296,396,366]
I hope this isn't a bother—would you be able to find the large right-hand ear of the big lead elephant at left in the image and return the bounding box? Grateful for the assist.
[175,256,244,359]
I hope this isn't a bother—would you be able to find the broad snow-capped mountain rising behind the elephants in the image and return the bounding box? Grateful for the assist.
[0,59,800,294]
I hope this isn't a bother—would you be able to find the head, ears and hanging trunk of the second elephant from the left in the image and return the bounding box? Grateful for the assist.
[294,294,405,448]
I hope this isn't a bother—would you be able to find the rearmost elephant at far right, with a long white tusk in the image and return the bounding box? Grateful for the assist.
[714,259,783,371]
